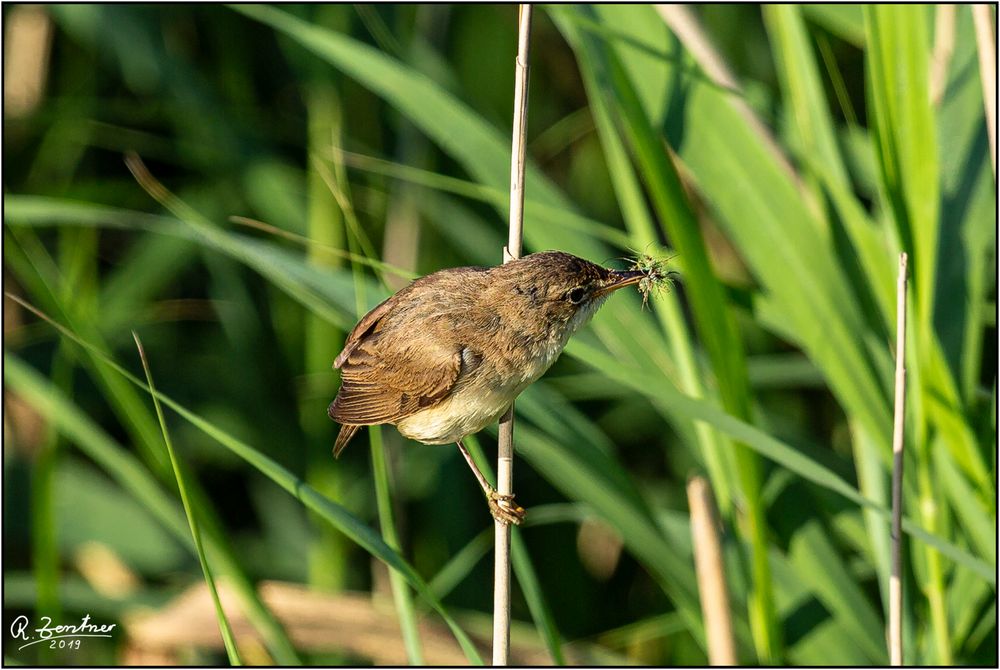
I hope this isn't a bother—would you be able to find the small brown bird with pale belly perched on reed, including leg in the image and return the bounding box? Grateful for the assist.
[327,251,648,524]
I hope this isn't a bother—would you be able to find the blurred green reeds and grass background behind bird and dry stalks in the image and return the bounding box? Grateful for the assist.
[2,4,997,666]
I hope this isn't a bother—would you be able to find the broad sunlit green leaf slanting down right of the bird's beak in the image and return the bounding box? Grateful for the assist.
[568,5,891,468]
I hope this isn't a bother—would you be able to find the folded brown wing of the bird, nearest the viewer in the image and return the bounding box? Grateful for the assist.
[329,333,462,425]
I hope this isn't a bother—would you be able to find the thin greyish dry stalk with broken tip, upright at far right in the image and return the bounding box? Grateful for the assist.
[889,253,906,666]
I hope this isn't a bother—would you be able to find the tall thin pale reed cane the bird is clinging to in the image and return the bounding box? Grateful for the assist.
[493,5,531,665]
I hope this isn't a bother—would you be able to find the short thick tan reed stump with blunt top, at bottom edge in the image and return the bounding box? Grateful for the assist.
[687,477,737,665]
